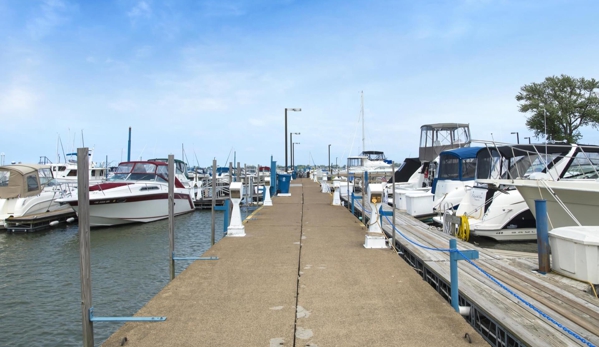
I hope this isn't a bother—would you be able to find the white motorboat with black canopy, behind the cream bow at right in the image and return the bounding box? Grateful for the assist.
[455,144,599,241]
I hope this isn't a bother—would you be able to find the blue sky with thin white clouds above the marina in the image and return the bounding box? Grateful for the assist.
[0,0,599,166]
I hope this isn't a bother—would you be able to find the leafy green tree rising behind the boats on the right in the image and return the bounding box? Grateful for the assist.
[516,75,599,143]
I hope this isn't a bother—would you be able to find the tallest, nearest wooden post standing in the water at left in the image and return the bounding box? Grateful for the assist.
[77,147,94,347]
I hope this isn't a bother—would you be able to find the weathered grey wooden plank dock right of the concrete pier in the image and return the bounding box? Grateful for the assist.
[342,190,599,346]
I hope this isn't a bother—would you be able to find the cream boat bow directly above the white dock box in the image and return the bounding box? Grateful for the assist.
[510,179,599,230]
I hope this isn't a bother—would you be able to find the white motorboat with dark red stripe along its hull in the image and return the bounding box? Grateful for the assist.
[59,161,195,227]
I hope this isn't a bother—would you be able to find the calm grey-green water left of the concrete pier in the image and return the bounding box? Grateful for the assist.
[0,208,251,347]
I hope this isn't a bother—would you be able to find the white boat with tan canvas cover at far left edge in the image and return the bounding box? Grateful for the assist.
[0,164,72,227]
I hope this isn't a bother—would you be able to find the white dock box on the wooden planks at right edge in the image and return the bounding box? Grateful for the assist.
[549,226,599,284]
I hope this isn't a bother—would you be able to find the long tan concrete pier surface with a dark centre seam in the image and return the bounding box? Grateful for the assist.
[102,179,488,347]
